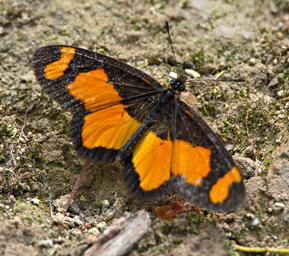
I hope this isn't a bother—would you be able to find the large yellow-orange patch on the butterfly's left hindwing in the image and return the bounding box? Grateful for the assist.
[81,104,140,149]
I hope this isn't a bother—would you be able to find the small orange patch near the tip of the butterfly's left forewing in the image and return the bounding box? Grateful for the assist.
[44,47,76,80]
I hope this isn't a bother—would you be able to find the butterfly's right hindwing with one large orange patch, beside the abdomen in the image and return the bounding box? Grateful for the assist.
[124,98,174,198]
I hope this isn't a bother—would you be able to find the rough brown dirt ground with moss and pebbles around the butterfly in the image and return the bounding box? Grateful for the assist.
[0,0,289,256]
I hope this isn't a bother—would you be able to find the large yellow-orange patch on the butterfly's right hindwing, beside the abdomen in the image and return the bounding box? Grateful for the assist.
[132,132,172,191]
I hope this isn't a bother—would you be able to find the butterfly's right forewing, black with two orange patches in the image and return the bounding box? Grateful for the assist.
[172,101,245,211]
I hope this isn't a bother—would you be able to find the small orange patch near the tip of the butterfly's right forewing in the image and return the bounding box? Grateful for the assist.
[210,166,241,204]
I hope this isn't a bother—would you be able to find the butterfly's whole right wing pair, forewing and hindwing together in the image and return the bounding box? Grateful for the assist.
[125,96,244,211]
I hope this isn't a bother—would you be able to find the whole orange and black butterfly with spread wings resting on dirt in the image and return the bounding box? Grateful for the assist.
[33,45,245,211]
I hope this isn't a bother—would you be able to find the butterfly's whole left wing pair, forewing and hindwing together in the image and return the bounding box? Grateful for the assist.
[33,45,163,162]
